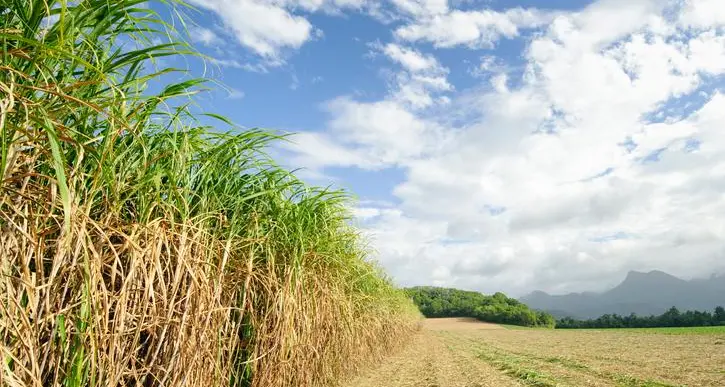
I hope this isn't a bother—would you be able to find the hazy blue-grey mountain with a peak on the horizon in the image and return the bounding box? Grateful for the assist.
[520,270,725,319]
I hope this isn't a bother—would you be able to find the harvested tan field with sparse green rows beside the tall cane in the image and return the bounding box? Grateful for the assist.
[346,319,725,387]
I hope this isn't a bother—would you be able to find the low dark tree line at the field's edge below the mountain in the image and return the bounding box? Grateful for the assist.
[556,306,725,329]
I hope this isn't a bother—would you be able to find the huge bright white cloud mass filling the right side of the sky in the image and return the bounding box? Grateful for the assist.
[288,0,725,295]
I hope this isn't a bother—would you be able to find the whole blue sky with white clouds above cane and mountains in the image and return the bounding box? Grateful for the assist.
[161,0,725,295]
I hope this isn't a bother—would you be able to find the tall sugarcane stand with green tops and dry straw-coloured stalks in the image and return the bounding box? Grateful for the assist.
[0,0,418,387]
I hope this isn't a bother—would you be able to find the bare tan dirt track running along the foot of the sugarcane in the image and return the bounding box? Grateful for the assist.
[346,319,522,387]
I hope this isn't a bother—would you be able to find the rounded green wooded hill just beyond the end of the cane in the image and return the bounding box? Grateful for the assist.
[405,286,555,328]
